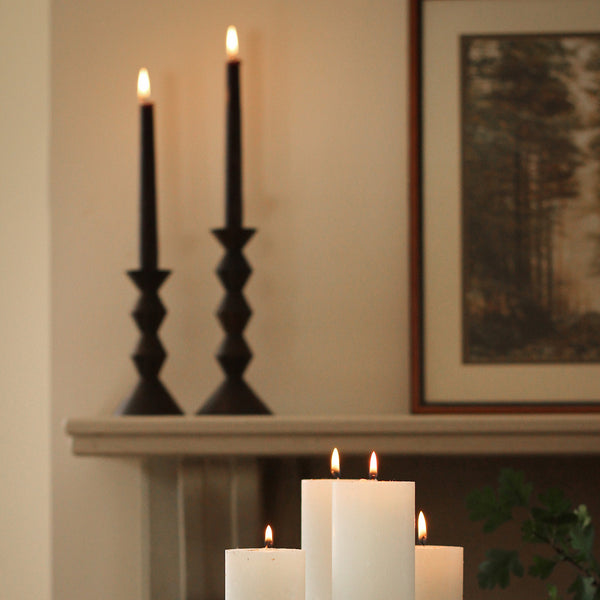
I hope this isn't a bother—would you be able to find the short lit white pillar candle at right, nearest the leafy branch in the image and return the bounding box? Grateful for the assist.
[415,512,463,600]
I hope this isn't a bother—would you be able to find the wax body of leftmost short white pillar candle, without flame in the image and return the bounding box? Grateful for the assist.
[225,524,305,600]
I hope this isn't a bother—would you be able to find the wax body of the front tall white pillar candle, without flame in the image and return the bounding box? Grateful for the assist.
[332,452,415,600]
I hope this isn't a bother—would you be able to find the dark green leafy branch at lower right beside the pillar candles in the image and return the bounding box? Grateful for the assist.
[467,469,600,600]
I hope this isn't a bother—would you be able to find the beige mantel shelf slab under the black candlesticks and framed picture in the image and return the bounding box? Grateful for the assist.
[66,414,600,457]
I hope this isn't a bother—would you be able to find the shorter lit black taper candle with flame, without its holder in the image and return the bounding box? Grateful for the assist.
[138,69,158,270]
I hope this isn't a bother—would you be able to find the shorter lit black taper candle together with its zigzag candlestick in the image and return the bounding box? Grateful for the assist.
[115,69,182,415]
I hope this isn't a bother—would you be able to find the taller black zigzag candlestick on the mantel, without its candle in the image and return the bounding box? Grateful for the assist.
[198,227,271,415]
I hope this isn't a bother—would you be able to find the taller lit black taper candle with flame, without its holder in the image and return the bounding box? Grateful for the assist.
[225,26,242,229]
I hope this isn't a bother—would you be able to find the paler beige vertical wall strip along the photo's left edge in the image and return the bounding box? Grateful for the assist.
[0,0,50,600]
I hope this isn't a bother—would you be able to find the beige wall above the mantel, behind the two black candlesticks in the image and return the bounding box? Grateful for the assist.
[53,0,407,414]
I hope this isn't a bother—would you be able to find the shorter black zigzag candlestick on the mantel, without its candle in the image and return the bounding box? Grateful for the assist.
[115,269,183,415]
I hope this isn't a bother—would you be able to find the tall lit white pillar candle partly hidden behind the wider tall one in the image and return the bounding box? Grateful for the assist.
[301,448,340,600]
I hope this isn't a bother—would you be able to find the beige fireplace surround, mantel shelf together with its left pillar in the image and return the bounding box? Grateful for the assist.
[66,415,600,600]
